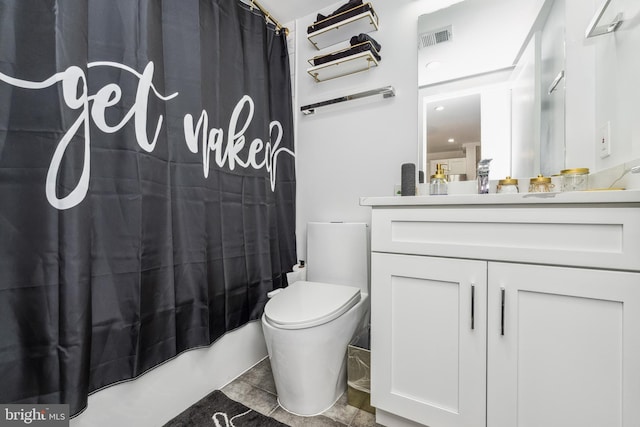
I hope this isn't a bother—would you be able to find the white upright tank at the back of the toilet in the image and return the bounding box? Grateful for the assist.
[307,222,369,293]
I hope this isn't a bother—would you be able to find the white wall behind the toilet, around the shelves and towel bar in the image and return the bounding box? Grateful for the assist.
[294,0,462,259]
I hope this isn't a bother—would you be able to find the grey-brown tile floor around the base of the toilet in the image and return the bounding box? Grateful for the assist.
[222,358,382,427]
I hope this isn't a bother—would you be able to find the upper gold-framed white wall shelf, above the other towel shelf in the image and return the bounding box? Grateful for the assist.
[307,4,378,50]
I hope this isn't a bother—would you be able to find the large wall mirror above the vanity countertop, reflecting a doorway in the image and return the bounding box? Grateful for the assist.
[418,0,565,181]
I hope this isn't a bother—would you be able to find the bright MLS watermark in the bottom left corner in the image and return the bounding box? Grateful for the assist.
[0,404,69,427]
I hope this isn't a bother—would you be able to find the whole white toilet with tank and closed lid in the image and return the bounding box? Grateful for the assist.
[262,223,369,416]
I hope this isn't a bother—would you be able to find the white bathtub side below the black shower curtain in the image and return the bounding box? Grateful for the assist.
[70,321,267,427]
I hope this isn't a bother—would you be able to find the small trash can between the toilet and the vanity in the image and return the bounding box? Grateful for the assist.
[347,328,376,414]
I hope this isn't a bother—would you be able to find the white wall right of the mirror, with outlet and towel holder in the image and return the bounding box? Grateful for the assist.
[566,0,640,171]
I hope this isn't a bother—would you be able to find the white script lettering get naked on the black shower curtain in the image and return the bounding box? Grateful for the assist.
[0,61,295,210]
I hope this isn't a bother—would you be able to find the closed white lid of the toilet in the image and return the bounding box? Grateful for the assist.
[264,281,360,329]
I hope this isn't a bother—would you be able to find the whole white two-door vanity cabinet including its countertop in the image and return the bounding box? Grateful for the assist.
[361,192,640,427]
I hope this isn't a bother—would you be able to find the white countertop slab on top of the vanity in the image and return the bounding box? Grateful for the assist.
[360,190,640,207]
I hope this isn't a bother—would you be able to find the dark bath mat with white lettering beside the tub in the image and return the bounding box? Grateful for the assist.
[164,390,288,427]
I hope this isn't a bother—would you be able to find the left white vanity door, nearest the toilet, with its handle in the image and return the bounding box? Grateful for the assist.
[371,253,487,427]
